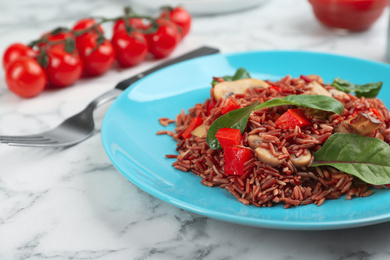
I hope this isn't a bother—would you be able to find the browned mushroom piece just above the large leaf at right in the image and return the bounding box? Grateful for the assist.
[335,113,382,136]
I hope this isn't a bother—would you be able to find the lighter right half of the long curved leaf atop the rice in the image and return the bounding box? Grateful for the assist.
[254,95,344,114]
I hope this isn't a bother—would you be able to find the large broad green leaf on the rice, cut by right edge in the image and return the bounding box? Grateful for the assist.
[312,133,390,185]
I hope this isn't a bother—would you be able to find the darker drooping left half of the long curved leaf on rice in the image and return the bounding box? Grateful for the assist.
[206,101,259,150]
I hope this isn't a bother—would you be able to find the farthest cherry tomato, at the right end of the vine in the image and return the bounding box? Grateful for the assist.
[160,6,192,38]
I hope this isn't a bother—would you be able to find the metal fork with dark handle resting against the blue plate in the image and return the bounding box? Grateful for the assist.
[0,47,219,147]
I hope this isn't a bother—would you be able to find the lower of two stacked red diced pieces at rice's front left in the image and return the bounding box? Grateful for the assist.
[224,146,253,175]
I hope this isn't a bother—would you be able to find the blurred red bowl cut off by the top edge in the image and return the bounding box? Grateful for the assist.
[309,0,389,31]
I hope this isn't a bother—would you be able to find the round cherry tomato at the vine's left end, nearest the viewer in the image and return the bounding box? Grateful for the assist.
[5,56,46,98]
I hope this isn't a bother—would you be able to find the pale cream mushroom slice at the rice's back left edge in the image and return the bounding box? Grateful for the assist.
[214,78,269,101]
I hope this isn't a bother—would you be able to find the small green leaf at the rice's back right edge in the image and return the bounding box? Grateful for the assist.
[332,78,383,98]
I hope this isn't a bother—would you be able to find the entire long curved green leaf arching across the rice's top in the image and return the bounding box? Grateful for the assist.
[206,95,344,150]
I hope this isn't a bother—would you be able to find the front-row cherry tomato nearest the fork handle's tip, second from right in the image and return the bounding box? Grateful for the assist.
[147,19,180,59]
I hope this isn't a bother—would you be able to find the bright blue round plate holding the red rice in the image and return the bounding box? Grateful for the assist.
[102,51,390,230]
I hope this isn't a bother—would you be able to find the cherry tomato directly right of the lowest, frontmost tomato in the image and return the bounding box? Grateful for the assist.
[45,44,83,88]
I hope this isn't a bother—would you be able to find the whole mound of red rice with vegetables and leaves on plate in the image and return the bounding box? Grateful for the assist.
[157,69,390,208]
